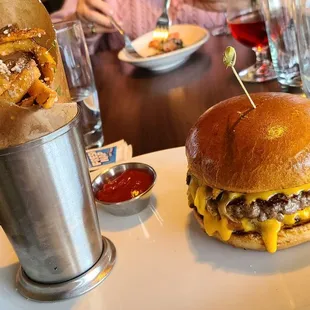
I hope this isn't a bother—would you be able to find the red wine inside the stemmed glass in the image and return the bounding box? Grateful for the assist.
[228,11,268,48]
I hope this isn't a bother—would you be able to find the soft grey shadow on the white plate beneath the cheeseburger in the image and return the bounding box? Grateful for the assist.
[187,212,310,275]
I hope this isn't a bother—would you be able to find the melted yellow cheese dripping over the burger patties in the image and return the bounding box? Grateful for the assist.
[189,181,310,253]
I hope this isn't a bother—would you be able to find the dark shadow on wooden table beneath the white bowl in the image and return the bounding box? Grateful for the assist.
[126,52,211,92]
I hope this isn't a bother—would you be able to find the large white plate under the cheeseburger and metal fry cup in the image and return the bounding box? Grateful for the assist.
[0,148,310,310]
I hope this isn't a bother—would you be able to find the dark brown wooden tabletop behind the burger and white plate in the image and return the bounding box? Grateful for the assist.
[92,36,281,155]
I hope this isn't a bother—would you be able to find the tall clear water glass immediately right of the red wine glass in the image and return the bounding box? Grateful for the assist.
[262,0,302,87]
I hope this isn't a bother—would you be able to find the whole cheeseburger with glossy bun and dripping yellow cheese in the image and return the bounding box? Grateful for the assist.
[186,93,310,253]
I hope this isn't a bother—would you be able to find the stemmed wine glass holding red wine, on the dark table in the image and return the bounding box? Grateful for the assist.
[227,0,276,82]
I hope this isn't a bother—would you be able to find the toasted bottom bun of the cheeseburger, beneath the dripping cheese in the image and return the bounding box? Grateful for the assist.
[194,210,310,251]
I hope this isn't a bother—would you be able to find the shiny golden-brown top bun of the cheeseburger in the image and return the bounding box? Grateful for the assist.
[186,93,310,193]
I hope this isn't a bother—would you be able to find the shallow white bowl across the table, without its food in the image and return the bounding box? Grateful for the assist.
[118,25,210,71]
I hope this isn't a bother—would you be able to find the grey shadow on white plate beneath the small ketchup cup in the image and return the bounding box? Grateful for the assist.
[97,195,157,231]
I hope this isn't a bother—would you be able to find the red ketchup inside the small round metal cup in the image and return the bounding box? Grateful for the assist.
[96,169,153,202]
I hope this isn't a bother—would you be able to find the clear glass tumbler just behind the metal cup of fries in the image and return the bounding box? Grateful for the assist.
[54,20,103,149]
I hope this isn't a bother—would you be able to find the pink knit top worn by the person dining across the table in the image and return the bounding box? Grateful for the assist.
[52,0,226,53]
